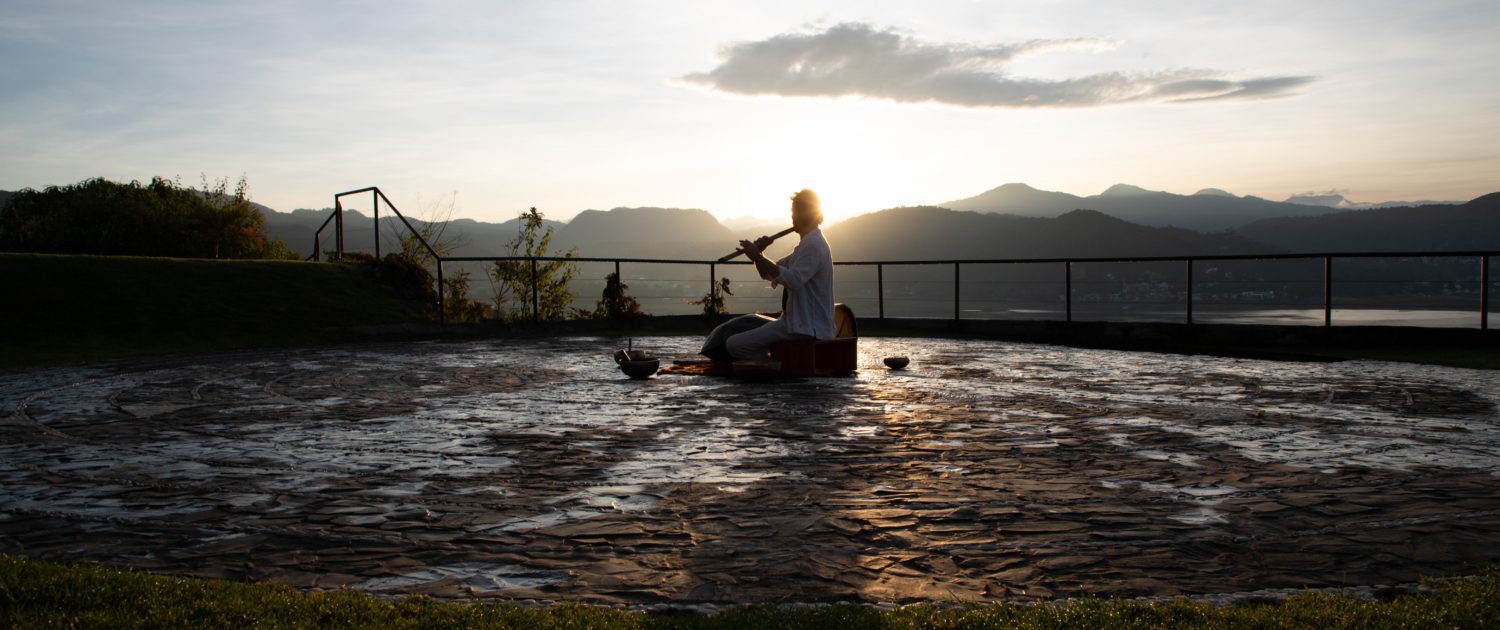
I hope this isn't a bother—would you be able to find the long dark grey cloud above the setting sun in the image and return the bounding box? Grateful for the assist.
[683,23,1313,108]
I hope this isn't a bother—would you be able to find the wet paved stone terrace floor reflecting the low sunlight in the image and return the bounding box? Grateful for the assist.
[0,338,1500,605]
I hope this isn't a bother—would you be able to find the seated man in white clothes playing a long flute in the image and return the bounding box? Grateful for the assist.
[702,189,834,360]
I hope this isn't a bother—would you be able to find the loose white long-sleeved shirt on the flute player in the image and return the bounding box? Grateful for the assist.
[771,230,836,339]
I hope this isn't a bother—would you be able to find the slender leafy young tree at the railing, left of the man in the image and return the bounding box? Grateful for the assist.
[491,209,578,321]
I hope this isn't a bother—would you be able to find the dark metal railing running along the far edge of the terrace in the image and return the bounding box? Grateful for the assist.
[311,186,1500,330]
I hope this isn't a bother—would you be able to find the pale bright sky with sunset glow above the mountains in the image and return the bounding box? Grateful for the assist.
[0,0,1500,226]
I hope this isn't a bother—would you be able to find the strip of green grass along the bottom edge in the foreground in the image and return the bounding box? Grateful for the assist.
[0,555,1500,629]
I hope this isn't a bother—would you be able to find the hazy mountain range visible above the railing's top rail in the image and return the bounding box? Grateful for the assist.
[0,183,1500,261]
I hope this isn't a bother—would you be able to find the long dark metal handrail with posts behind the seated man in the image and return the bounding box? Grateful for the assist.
[312,186,1500,330]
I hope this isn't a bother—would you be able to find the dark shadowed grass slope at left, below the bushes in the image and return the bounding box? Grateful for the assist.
[0,254,426,369]
